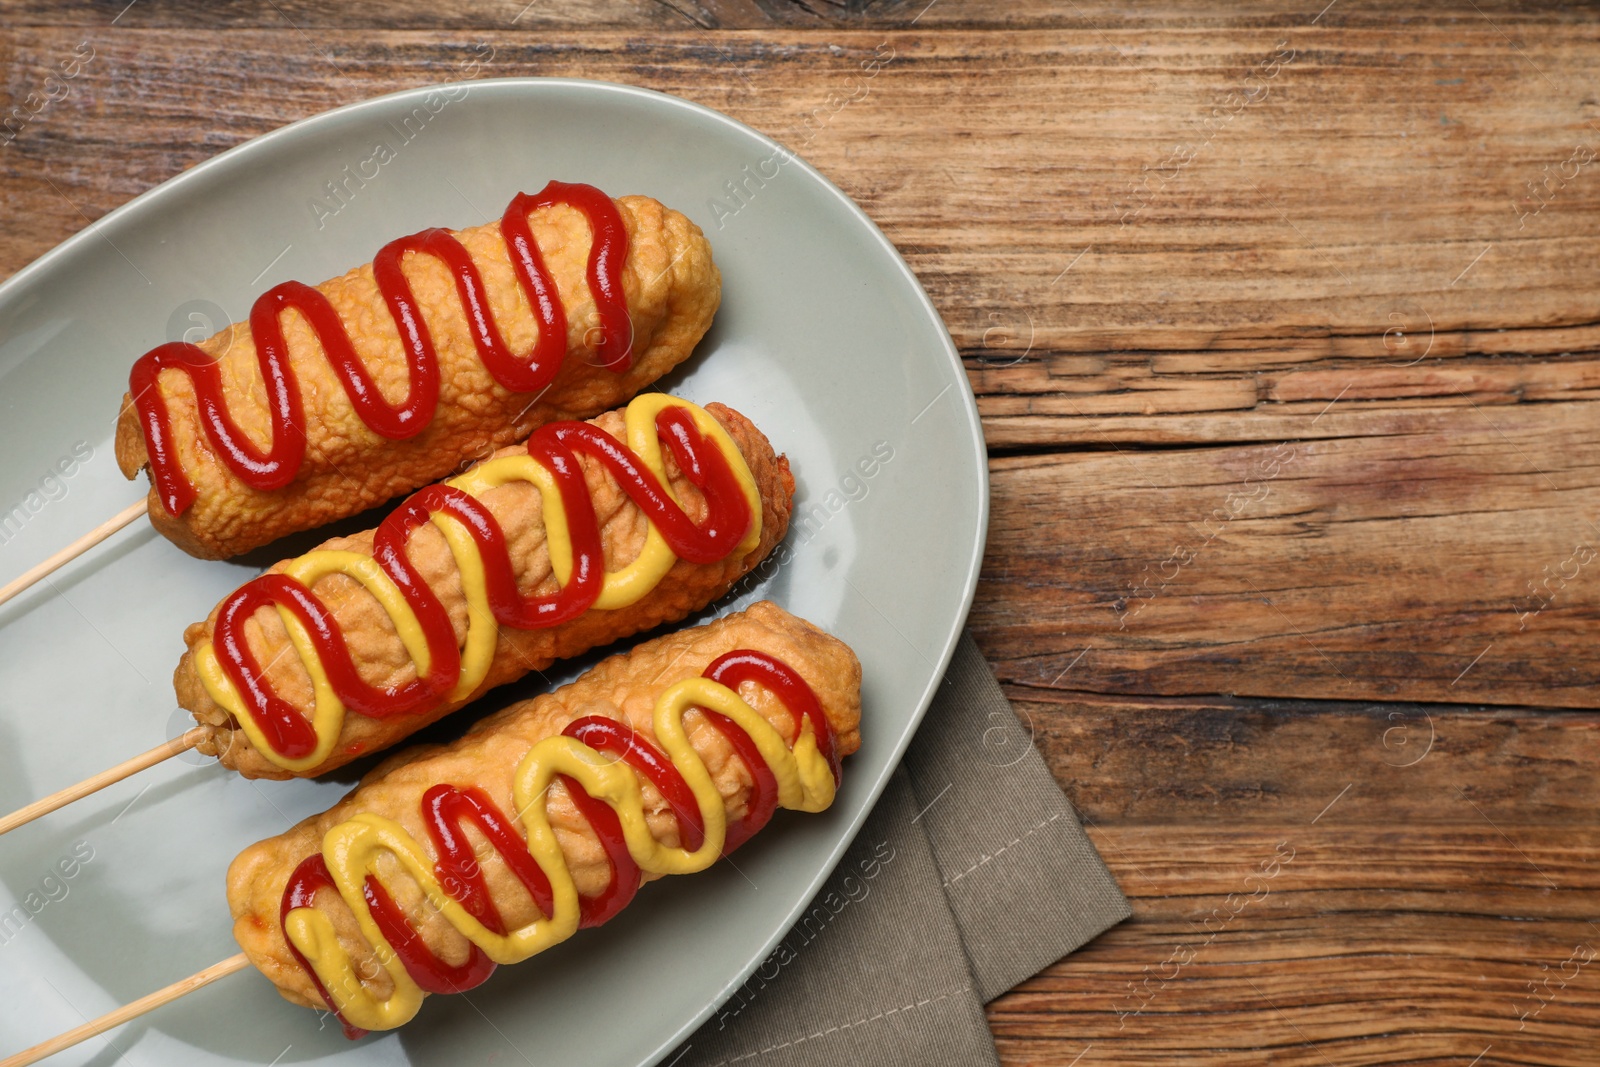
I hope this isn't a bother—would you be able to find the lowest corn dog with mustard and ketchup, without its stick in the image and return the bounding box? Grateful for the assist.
[227,601,861,1037]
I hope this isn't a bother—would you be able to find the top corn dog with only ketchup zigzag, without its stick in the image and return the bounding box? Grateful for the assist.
[115,182,722,558]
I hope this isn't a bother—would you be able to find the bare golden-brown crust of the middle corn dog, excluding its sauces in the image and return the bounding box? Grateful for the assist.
[173,403,794,779]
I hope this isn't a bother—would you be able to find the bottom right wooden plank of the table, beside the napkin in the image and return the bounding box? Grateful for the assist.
[990,688,1600,1067]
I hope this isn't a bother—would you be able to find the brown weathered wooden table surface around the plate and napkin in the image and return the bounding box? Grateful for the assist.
[0,0,1600,1067]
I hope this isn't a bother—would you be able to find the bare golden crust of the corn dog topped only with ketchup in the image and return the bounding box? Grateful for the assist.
[117,197,722,560]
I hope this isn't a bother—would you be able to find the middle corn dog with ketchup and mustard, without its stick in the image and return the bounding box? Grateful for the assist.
[174,394,794,779]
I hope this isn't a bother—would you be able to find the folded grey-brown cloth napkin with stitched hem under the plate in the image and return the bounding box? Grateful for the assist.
[664,633,1130,1067]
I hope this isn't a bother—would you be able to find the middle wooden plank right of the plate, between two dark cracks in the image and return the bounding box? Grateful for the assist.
[973,402,1600,707]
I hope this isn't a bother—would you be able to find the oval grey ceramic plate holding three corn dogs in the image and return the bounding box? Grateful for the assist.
[0,80,987,1064]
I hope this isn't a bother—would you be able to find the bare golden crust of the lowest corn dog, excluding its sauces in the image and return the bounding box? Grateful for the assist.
[227,601,861,1008]
